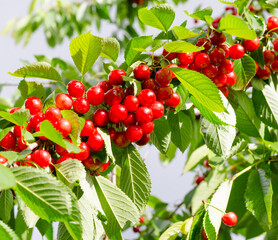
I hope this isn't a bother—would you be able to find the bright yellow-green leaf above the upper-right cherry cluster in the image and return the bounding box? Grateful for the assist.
[218,14,256,40]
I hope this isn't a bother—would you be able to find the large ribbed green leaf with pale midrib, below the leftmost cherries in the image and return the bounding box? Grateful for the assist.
[12,167,74,222]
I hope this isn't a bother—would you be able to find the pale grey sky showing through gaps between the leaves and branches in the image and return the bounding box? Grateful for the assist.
[0,0,258,240]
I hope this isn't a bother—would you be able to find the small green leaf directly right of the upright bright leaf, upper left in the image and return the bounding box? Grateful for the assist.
[100,37,120,62]
